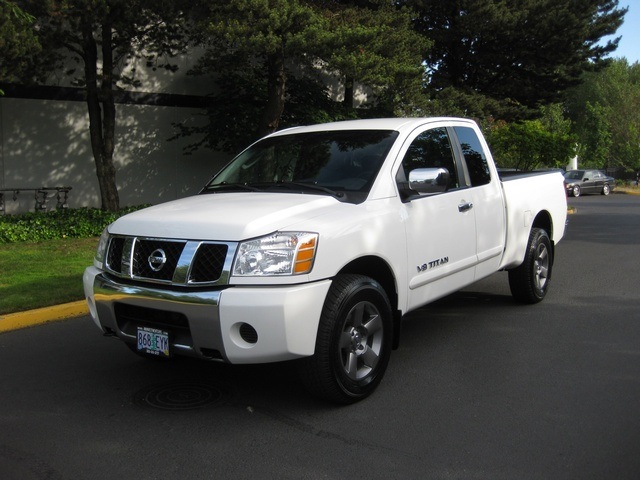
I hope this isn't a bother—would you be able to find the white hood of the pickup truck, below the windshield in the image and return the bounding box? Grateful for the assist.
[109,192,344,241]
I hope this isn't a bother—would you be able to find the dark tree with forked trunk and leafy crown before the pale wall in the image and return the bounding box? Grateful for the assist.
[24,0,192,211]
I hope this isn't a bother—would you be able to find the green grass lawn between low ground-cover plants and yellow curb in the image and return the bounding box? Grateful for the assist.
[0,238,98,315]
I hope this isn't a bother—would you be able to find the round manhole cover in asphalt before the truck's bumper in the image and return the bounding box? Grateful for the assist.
[133,382,224,410]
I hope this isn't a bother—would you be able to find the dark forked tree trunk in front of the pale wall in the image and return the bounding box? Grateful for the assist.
[82,17,120,212]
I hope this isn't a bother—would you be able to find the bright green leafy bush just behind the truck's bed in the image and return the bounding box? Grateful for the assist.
[487,105,575,170]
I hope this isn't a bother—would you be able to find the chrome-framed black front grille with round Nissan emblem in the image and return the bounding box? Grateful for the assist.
[105,235,237,286]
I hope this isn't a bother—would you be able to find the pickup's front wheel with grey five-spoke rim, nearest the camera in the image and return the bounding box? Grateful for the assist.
[299,275,392,404]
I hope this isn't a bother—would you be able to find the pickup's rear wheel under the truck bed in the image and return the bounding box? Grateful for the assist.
[509,228,553,304]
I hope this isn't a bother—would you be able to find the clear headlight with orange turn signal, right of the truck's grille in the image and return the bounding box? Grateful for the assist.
[233,232,318,276]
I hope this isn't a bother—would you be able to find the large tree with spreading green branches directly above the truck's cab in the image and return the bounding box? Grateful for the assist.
[181,0,428,150]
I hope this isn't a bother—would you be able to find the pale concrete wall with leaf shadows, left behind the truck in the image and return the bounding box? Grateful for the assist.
[0,98,229,213]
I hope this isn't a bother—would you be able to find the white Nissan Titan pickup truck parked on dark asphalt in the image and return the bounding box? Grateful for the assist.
[84,118,567,403]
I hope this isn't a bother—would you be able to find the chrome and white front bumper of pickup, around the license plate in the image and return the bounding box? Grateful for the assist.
[83,267,331,363]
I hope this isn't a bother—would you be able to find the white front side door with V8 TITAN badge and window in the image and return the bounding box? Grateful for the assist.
[396,127,477,309]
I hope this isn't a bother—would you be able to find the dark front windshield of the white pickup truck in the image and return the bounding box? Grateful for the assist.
[205,130,398,196]
